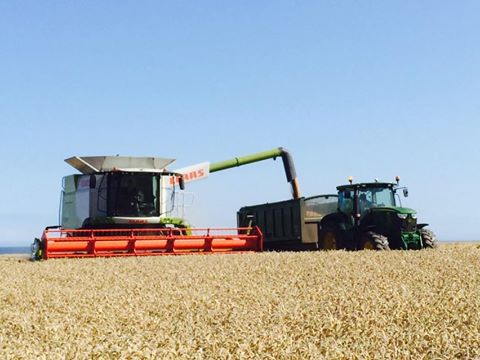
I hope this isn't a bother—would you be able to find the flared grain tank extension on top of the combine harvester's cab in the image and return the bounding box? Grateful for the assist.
[65,156,175,174]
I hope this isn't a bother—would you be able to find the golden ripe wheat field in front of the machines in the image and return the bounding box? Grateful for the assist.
[0,245,480,359]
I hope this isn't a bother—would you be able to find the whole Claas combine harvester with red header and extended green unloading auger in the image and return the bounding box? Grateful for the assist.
[32,148,300,260]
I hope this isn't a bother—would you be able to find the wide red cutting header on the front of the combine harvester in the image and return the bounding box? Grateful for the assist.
[40,227,263,260]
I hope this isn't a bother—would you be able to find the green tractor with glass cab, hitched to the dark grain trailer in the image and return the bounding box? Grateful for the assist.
[319,177,437,250]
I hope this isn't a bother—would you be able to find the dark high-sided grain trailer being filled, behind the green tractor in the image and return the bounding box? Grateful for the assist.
[237,195,338,250]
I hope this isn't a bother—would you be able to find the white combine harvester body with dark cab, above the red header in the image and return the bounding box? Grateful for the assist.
[60,156,183,228]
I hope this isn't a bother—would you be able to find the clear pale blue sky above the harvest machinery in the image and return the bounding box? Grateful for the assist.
[0,1,480,246]
